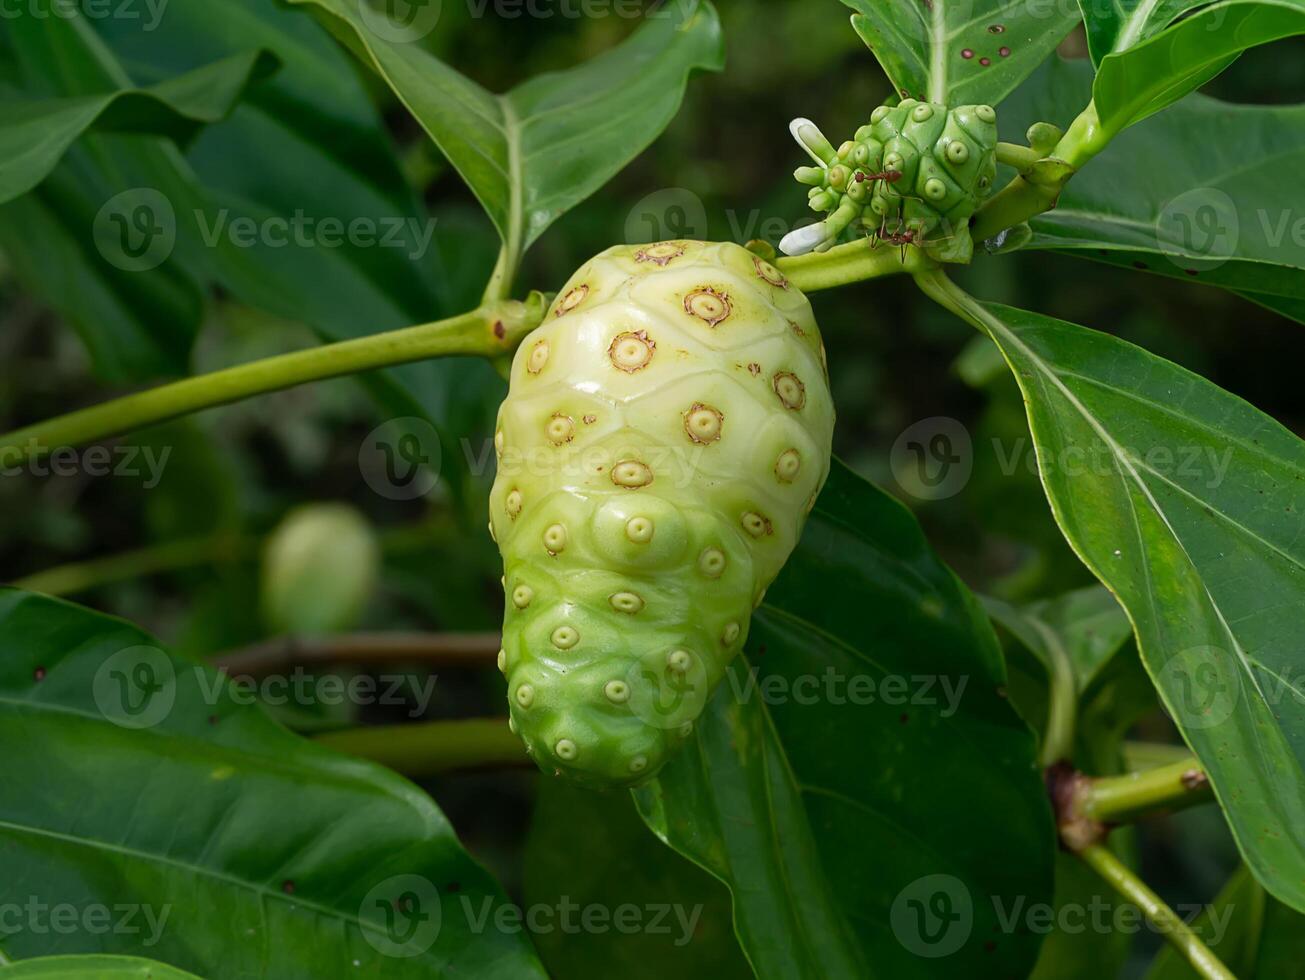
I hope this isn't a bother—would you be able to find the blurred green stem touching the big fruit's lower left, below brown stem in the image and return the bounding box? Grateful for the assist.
[315,718,530,778]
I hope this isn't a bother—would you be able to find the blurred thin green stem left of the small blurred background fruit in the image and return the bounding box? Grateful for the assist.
[10,534,258,595]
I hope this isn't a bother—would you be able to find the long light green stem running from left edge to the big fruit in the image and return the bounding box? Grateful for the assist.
[0,292,548,466]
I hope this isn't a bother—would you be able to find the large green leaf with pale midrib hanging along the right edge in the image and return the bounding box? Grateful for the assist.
[988,298,1305,908]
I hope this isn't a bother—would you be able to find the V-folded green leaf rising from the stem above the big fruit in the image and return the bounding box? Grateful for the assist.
[291,0,723,264]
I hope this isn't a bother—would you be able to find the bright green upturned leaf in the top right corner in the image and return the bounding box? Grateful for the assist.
[1079,0,1305,141]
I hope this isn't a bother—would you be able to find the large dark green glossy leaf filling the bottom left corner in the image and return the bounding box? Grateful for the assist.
[0,590,543,980]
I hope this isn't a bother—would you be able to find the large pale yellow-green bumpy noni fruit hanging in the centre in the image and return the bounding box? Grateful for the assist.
[489,241,834,786]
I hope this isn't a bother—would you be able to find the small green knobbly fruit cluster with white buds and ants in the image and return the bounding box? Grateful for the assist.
[780,99,997,262]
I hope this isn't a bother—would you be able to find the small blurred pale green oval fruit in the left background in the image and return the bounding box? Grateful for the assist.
[261,504,381,634]
